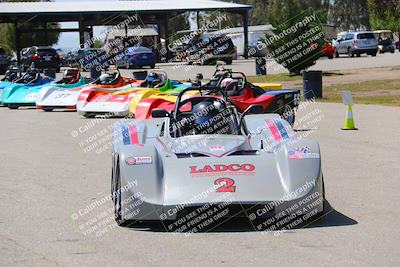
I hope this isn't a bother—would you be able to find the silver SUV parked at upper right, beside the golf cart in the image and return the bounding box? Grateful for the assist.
[335,32,378,57]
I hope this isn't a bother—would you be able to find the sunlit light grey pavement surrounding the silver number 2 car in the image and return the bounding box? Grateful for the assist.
[0,104,400,266]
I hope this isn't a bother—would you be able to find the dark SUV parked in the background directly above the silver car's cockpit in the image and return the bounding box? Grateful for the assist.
[187,33,237,65]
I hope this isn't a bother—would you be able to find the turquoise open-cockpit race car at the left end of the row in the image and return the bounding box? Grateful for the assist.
[1,69,53,109]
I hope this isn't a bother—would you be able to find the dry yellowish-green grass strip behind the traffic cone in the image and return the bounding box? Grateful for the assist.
[319,79,400,106]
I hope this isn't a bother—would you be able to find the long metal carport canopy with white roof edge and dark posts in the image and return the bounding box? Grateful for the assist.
[0,0,252,58]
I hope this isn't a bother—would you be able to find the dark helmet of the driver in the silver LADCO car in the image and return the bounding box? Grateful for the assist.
[192,99,225,125]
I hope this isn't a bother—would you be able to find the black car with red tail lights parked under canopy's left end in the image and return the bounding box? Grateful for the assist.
[21,46,61,72]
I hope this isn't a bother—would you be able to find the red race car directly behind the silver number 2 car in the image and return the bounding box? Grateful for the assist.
[135,69,300,125]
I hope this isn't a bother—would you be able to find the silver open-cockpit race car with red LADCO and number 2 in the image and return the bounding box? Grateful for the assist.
[111,88,324,232]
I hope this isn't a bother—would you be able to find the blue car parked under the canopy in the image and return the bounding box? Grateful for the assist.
[115,46,156,69]
